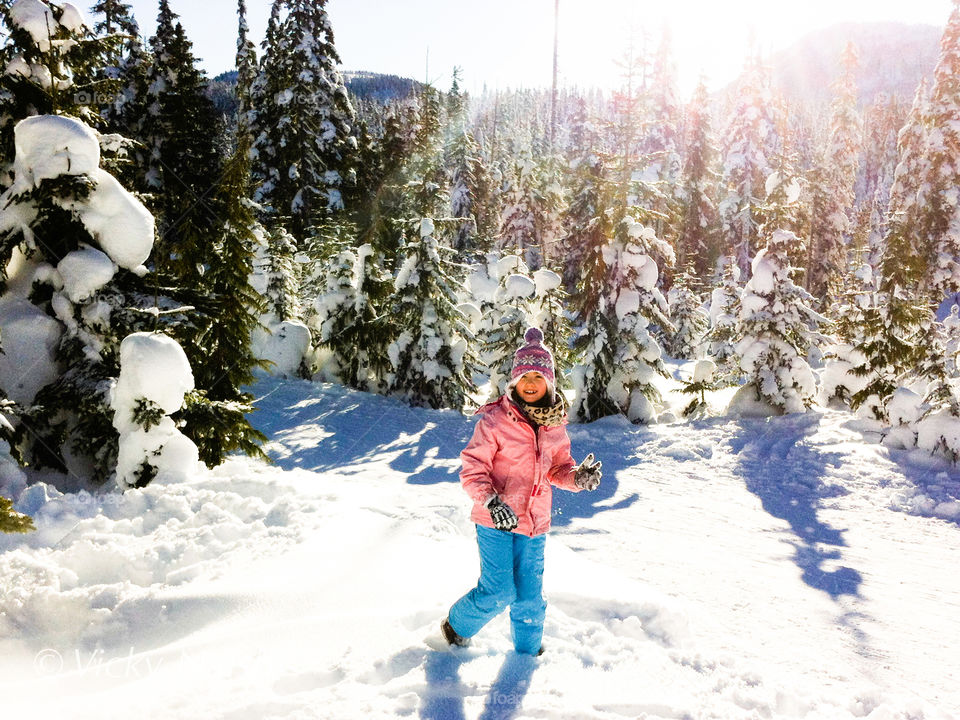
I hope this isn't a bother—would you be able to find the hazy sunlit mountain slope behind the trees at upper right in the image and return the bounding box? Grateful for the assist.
[769,23,943,105]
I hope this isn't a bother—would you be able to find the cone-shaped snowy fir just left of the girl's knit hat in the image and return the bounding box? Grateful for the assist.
[386,218,474,410]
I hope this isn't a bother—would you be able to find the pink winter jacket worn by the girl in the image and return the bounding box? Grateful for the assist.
[460,395,579,537]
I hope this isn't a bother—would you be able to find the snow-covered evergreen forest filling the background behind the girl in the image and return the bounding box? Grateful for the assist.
[0,0,960,530]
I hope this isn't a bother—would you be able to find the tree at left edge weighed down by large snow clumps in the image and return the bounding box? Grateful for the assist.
[0,115,158,482]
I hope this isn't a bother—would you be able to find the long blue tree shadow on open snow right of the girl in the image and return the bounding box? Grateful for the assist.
[730,413,863,600]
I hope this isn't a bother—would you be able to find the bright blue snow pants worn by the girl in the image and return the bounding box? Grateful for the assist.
[449,525,547,655]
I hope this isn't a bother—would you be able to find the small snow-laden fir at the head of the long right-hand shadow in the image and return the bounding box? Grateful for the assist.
[736,230,824,413]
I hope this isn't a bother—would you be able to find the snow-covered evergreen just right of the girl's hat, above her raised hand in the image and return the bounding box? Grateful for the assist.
[571,217,674,422]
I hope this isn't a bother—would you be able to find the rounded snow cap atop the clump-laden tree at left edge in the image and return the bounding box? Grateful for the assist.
[11,113,100,186]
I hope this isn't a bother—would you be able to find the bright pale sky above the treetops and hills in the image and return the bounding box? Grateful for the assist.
[122,0,952,95]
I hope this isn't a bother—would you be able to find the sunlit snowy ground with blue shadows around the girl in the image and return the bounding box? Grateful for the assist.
[0,372,960,720]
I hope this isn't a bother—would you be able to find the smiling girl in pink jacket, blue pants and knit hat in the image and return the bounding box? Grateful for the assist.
[441,328,601,655]
